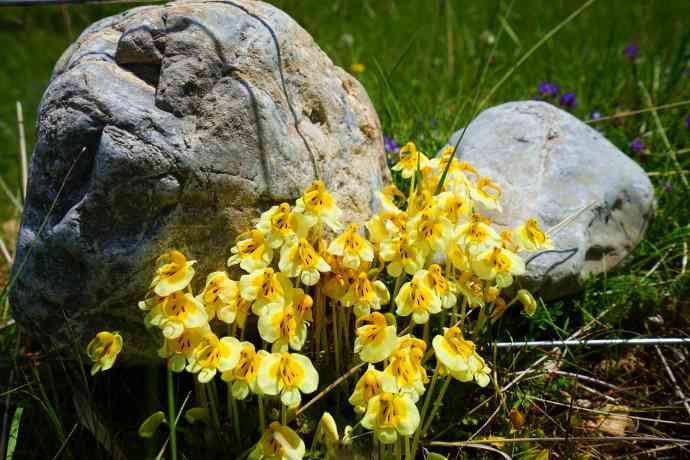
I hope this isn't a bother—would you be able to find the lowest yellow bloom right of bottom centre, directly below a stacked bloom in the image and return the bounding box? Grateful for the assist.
[362,393,419,444]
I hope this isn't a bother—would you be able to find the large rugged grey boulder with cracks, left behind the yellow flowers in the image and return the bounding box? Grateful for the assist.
[11,0,388,358]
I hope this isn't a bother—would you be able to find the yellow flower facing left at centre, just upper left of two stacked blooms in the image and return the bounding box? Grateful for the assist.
[355,312,398,363]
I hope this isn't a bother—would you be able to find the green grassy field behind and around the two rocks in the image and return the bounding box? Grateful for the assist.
[0,0,690,458]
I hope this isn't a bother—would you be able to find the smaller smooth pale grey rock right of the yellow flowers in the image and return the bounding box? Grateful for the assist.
[440,101,656,300]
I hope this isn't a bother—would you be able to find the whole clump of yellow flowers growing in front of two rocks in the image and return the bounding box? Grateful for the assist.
[80,142,553,459]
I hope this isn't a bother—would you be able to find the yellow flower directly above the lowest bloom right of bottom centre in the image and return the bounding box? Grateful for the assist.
[383,335,428,402]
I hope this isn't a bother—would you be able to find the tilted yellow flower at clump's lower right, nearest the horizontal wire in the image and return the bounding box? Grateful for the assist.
[432,326,491,387]
